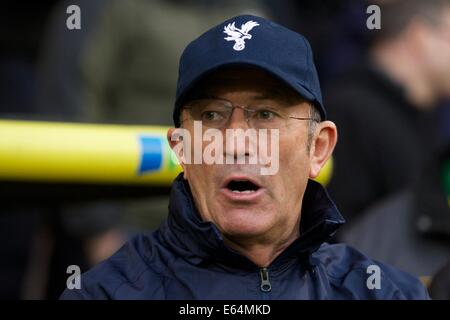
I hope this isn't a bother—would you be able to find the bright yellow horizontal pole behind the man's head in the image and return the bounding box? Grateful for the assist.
[0,120,332,186]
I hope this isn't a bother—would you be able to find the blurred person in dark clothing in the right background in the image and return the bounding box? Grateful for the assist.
[325,0,450,222]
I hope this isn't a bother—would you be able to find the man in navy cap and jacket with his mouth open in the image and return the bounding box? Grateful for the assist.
[62,15,428,299]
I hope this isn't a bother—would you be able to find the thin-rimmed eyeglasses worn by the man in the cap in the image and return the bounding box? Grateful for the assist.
[183,99,318,129]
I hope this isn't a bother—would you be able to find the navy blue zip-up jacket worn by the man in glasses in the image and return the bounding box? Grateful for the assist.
[61,175,428,299]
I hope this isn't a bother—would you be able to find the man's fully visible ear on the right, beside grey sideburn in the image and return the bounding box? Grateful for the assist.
[309,121,337,179]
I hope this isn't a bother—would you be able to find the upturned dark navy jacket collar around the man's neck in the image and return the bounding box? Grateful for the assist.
[160,173,345,269]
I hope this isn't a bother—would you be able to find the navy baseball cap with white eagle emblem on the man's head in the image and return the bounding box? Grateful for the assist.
[173,15,326,127]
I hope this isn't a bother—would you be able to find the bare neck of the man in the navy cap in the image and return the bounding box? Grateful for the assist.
[225,217,300,267]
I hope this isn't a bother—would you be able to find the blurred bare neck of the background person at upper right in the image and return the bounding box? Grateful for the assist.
[371,42,436,110]
